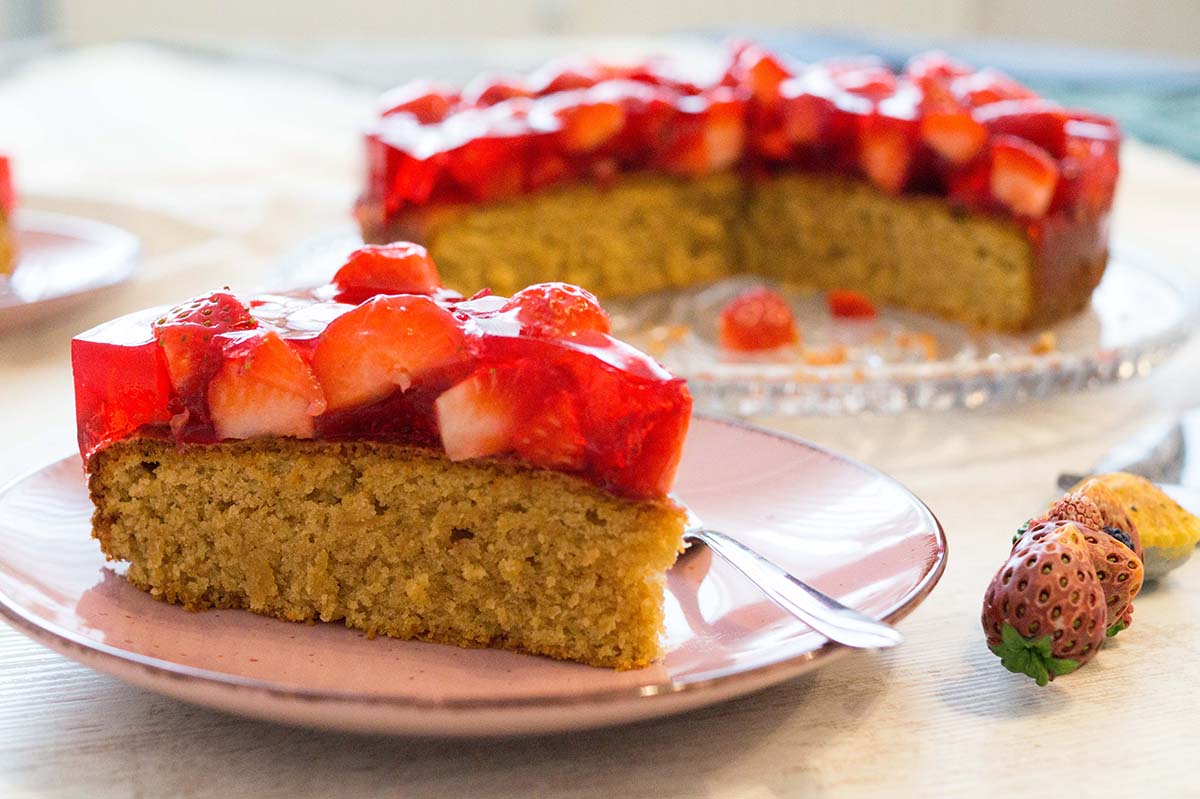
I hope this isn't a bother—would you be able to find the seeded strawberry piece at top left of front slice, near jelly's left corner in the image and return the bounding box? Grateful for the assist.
[150,292,258,395]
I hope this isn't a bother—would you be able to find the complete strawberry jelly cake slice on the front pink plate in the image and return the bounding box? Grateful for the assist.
[72,244,691,668]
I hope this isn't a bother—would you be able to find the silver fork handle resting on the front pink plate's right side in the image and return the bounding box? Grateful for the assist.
[683,518,904,649]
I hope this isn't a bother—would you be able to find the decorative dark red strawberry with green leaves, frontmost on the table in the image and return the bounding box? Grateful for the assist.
[980,522,1106,685]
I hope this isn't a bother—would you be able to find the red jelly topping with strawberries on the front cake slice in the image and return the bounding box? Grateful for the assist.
[72,244,691,498]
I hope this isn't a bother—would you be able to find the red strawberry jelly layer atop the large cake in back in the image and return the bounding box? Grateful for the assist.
[358,43,1120,227]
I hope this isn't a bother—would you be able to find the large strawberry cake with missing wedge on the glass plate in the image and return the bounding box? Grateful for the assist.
[356,44,1120,330]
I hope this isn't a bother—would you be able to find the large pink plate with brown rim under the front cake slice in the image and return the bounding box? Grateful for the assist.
[0,417,946,737]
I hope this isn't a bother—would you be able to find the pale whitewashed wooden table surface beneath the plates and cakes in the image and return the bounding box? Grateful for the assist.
[0,46,1200,799]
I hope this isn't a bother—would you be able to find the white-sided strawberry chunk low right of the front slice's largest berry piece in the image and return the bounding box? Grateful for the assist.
[433,366,523,461]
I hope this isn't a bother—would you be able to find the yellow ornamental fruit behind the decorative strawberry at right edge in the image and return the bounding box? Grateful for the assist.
[1072,471,1200,579]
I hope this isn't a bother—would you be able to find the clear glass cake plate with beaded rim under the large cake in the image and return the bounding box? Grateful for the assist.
[272,229,1198,416]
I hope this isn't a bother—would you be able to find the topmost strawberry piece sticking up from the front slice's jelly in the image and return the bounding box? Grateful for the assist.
[334,241,442,305]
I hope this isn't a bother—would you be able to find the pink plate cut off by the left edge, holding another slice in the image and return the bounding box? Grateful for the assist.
[0,209,142,332]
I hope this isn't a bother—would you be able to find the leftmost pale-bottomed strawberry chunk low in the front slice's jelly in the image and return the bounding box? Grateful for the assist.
[208,331,325,438]
